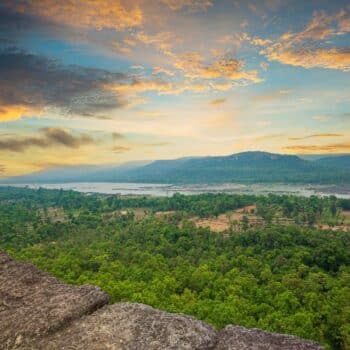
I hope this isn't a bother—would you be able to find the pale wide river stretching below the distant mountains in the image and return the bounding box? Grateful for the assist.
[3,182,350,198]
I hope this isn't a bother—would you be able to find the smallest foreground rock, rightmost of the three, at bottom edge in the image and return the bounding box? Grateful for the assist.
[215,325,323,350]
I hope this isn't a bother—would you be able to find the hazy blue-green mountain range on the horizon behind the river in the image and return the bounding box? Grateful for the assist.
[1,152,350,184]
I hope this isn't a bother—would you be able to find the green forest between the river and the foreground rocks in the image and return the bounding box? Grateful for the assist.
[0,187,350,350]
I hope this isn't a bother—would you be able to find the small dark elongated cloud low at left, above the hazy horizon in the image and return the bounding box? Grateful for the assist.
[0,128,94,152]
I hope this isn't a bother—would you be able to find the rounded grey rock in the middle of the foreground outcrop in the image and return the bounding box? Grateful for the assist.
[34,303,216,350]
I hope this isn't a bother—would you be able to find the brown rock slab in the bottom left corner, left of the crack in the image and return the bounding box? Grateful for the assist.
[0,251,109,349]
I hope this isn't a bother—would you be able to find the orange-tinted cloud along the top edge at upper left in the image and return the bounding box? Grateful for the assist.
[3,0,143,30]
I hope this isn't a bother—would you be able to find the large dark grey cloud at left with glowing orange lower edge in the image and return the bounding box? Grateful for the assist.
[0,49,127,121]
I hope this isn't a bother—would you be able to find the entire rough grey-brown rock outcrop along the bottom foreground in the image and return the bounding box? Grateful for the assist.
[0,251,322,350]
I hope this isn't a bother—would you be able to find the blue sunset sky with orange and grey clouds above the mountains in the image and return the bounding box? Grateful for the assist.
[0,0,350,177]
